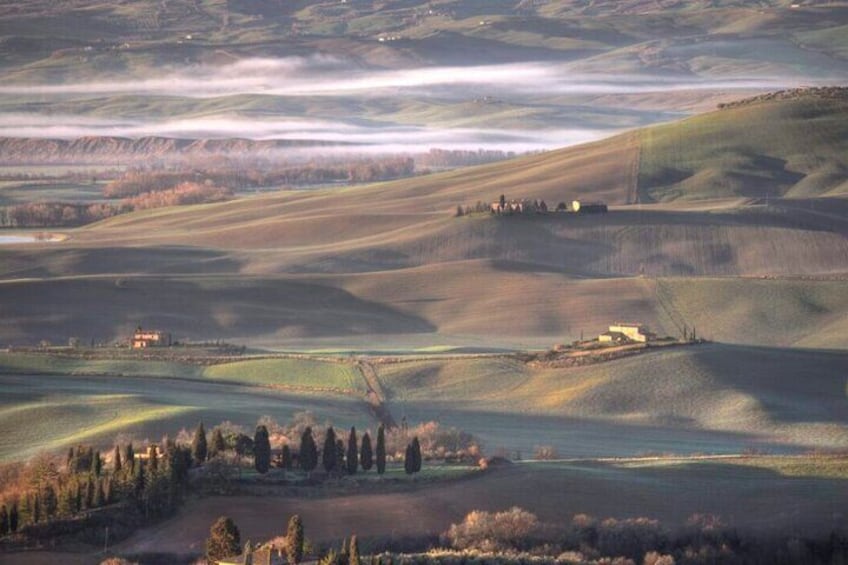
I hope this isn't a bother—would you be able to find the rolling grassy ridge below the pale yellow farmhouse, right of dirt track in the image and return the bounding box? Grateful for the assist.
[379,345,848,456]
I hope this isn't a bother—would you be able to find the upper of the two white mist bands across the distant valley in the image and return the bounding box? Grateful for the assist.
[0,57,798,98]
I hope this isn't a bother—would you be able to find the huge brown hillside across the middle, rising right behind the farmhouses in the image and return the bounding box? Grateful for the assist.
[0,95,848,349]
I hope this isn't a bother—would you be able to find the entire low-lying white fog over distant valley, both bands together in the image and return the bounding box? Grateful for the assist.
[0,57,816,153]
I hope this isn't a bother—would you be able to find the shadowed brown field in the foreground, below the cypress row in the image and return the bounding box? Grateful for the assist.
[96,460,848,553]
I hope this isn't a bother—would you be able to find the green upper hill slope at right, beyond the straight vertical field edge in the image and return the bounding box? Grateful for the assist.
[639,96,848,202]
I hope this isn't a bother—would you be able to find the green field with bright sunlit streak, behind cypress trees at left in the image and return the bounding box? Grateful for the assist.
[0,375,376,461]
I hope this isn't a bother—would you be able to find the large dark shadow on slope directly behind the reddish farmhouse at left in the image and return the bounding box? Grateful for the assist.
[0,276,435,344]
